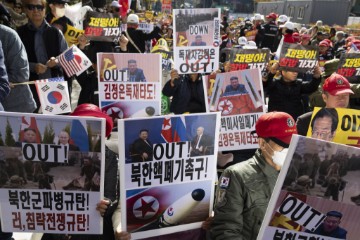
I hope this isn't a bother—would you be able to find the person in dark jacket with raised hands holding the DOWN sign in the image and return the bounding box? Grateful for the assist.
[162,69,206,114]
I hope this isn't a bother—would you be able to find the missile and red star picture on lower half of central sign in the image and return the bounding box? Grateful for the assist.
[126,181,211,232]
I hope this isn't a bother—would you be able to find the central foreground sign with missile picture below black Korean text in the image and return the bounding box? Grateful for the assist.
[118,113,220,239]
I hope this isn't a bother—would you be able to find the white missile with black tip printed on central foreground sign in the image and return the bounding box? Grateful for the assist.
[136,188,205,231]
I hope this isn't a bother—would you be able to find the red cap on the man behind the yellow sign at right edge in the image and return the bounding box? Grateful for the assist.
[323,73,354,96]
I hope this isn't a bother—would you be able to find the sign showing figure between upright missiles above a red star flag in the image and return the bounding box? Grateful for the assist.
[206,69,265,151]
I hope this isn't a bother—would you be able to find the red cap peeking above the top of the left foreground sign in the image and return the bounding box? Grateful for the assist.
[70,103,114,137]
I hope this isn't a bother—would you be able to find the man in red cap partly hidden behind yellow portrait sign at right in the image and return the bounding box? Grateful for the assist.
[296,73,354,136]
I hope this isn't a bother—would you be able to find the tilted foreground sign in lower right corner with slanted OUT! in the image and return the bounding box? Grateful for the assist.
[257,135,360,240]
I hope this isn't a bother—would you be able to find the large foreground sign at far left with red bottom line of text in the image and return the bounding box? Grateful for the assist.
[0,112,105,234]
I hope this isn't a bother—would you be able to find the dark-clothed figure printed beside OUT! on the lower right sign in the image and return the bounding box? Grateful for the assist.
[306,211,347,239]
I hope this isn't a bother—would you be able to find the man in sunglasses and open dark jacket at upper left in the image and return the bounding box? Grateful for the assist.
[17,0,67,112]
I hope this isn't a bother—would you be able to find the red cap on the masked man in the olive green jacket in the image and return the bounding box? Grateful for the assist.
[255,112,297,147]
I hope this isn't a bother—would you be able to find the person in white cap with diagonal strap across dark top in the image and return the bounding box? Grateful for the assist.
[123,14,161,53]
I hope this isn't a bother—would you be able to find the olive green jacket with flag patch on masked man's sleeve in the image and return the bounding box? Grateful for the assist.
[210,149,279,240]
